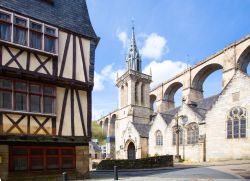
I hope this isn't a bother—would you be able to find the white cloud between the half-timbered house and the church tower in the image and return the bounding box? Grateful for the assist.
[94,63,125,91]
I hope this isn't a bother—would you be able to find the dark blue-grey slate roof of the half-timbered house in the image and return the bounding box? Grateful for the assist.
[0,0,99,40]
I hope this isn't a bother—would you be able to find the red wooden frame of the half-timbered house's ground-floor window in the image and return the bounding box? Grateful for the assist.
[9,146,76,172]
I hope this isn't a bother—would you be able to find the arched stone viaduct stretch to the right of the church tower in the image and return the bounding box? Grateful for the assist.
[150,35,250,112]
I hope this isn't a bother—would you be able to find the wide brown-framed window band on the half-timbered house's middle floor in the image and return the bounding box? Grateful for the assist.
[0,78,56,114]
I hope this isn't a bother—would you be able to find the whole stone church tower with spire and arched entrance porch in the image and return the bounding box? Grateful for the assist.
[115,27,152,159]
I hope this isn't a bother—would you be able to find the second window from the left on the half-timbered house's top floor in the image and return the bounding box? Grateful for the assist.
[14,16,28,45]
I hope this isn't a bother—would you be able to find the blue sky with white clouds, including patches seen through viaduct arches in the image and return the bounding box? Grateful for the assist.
[87,0,250,119]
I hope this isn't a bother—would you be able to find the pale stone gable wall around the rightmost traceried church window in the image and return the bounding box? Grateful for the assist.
[206,71,250,161]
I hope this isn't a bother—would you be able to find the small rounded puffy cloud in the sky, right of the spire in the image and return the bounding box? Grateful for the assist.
[140,33,168,60]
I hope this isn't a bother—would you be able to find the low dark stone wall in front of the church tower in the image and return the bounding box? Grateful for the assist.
[96,155,173,170]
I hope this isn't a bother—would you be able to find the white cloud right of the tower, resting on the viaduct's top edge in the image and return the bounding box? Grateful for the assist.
[143,60,189,88]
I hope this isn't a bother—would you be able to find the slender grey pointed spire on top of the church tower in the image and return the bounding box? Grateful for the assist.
[126,25,141,72]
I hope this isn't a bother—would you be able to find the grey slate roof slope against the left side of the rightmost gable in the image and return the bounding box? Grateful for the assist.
[189,95,219,119]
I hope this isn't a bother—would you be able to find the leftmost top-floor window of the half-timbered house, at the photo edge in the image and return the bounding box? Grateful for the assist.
[0,12,11,41]
